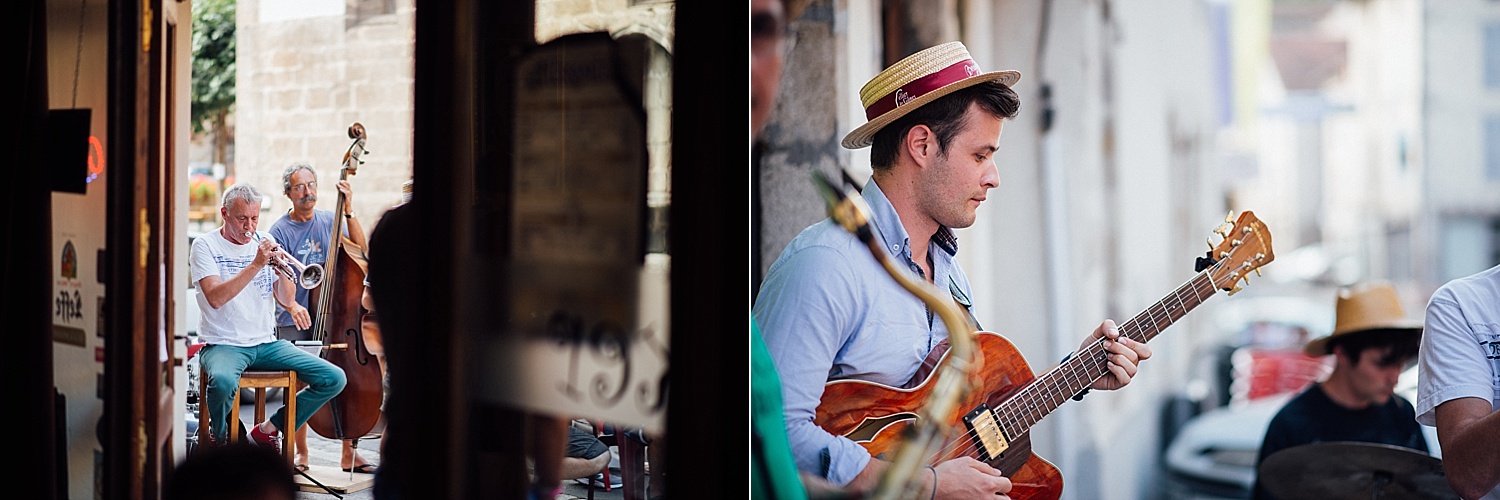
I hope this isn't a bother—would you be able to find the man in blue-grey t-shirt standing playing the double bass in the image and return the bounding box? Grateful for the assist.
[270,164,375,474]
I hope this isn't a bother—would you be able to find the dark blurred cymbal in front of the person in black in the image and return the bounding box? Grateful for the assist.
[1259,441,1458,500]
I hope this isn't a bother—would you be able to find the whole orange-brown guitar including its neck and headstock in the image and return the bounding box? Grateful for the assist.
[813,207,1275,500]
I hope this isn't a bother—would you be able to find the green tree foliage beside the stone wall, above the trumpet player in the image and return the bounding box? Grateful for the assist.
[192,0,236,136]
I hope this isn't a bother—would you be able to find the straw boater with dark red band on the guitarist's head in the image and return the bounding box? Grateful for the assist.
[843,42,1022,149]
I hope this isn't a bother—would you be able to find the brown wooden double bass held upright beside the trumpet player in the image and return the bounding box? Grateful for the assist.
[308,122,384,440]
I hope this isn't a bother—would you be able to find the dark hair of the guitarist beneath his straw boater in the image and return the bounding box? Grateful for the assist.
[870,81,1022,170]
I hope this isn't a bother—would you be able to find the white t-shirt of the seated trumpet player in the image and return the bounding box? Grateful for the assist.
[191,228,276,347]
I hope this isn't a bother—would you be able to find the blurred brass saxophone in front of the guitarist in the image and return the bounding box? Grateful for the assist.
[813,171,978,500]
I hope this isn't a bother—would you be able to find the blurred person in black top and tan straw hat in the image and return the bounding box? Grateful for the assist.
[1254,282,1428,498]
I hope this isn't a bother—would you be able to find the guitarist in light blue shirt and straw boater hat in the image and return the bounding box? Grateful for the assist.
[753,42,1151,498]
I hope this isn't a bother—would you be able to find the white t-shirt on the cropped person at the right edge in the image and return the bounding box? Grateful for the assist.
[1416,266,1500,500]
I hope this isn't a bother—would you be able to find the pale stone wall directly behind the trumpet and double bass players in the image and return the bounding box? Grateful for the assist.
[234,0,416,231]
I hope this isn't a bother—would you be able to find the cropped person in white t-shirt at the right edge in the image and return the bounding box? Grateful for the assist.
[1416,261,1500,498]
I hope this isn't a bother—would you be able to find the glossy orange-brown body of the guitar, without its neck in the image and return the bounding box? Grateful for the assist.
[813,332,1062,500]
